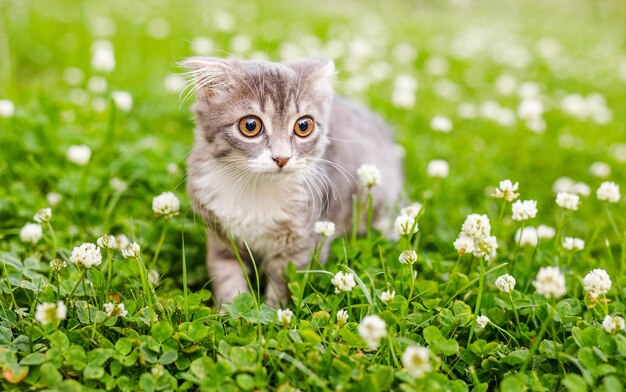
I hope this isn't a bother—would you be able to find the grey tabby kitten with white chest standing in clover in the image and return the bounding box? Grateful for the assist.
[184,57,403,306]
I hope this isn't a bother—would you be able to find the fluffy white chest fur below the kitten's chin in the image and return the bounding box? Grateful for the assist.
[191,164,303,254]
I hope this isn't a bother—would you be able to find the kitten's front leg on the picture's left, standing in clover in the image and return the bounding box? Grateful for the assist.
[207,234,250,307]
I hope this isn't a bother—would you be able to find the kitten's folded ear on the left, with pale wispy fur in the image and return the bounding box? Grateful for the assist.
[181,57,236,98]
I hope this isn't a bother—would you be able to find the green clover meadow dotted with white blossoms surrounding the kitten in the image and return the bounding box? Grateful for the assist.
[0,0,626,392]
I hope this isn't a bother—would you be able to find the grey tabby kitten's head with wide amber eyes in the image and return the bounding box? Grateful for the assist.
[183,57,334,176]
